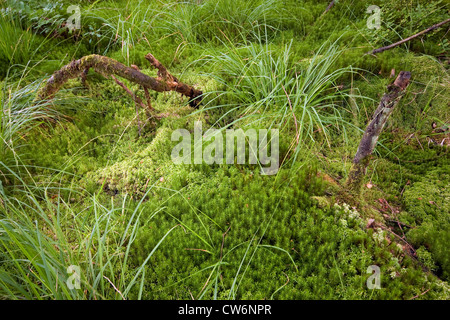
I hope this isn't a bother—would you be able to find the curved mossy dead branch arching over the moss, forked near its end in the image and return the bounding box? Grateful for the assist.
[37,54,203,108]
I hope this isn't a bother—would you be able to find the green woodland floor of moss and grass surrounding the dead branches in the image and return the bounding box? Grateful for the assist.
[0,0,450,300]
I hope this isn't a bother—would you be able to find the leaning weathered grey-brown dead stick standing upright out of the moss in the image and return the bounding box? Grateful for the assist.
[346,71,411,195]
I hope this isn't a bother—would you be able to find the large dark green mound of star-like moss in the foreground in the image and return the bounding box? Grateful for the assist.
[121,162,448,299]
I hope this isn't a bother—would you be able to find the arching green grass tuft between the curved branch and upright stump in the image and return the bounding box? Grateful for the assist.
[195,36,355,168]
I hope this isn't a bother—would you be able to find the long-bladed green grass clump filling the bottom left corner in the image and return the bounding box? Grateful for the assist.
[0,168,177,300]
